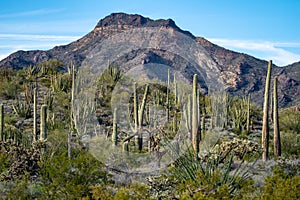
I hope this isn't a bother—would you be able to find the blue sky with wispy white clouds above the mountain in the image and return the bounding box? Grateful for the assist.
[0,0,300,66]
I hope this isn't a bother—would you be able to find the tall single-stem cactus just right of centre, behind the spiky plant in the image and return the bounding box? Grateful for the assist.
[192,74,200,155]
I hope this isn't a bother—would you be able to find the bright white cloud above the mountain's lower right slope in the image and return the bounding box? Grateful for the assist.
[208,38,300,66]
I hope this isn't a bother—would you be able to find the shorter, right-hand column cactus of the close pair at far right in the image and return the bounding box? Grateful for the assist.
[273,77,281,156]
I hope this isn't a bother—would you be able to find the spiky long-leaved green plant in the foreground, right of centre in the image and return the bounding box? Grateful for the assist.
[171,144,250,196]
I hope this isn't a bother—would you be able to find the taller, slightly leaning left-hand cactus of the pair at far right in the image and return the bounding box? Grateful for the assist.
[262,60,272,161]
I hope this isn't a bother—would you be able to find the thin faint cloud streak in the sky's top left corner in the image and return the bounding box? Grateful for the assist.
[0,9,63,18]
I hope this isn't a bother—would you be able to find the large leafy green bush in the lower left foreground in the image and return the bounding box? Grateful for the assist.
[41,149,110,199]
